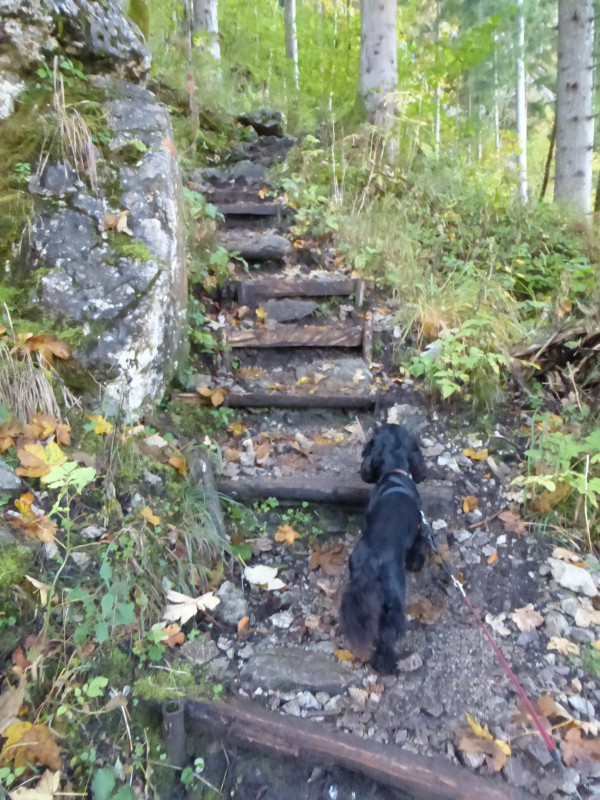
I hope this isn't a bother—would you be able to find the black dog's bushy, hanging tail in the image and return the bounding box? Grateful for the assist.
[340,562,383,661]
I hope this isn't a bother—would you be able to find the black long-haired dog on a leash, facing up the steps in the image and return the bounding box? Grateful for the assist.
[340,424,427,673]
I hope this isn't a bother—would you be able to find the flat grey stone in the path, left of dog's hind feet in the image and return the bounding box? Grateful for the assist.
[240,647,360,694]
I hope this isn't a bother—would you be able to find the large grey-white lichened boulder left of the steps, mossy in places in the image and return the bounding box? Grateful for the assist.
[27,82,187,414]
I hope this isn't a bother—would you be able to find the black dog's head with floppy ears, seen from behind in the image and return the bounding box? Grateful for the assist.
[360,423,426,483]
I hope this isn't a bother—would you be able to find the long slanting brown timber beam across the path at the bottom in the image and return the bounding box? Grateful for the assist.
[185,700,532,800]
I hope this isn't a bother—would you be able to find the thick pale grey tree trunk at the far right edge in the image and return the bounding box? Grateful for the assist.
[554,0,594,214]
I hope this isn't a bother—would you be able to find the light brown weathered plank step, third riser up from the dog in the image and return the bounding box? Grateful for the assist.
[227,325,363,347]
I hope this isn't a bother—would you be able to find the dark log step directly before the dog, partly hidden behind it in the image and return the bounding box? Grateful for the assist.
[217,473,454,519]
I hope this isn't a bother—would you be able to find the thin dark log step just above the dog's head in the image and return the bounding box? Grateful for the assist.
[174,392,380,411]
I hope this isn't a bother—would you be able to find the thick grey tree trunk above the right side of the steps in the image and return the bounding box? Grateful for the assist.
[359,0,398,121]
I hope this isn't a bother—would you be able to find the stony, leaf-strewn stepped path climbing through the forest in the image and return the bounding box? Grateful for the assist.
[170,119,600,800]
